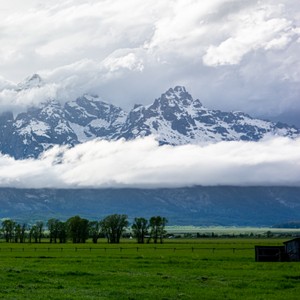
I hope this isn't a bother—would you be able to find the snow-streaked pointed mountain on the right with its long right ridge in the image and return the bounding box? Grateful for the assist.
[121,86,299,145]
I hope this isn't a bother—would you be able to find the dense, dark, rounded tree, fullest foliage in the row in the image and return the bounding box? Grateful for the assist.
[67,216,89,243]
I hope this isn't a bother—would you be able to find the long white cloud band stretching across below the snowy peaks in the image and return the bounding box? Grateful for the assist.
[0,137,300,188]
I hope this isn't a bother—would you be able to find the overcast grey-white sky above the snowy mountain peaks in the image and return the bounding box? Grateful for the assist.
[0,0,300,127]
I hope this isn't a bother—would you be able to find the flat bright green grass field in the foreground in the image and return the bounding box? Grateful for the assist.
[0,239,300,300]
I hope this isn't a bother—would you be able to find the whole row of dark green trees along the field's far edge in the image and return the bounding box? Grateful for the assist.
[0,214,168,244]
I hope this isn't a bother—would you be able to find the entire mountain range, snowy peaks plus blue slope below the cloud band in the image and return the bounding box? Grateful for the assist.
[0,74,300,226]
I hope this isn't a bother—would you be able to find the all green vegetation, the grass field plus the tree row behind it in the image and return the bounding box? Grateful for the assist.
[0,215,300,300]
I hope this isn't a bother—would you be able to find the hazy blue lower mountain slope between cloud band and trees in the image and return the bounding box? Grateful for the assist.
[0,186,300,226]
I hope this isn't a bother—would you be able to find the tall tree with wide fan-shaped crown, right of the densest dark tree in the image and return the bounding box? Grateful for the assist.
[100,214,129,244]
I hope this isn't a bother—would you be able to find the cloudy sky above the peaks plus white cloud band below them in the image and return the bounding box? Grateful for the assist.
[0,0,300,188]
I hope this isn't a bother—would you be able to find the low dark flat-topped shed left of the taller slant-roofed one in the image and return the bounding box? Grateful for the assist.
[255,246,287,261]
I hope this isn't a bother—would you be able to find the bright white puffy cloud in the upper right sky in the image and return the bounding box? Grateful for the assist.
[203,5,298,66]
